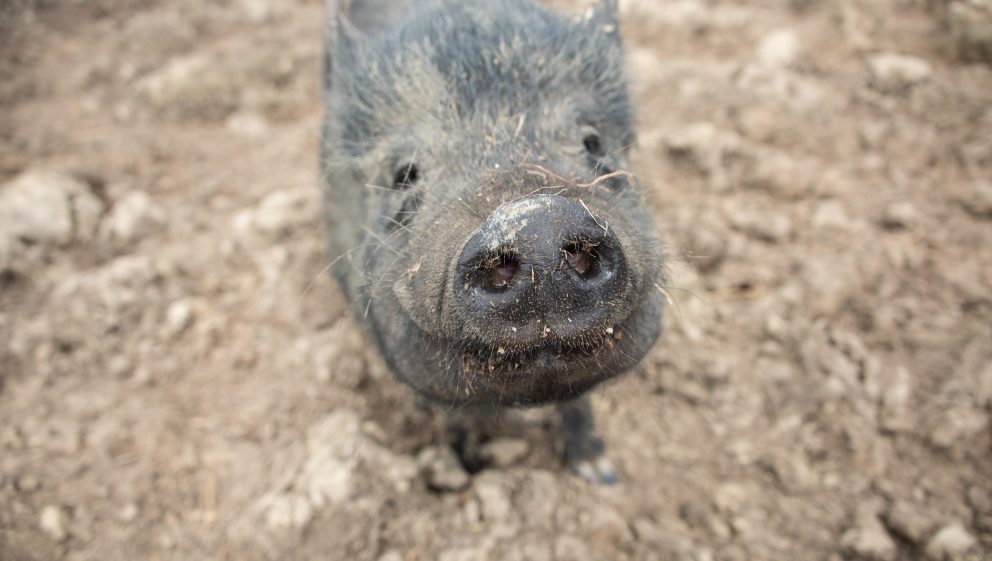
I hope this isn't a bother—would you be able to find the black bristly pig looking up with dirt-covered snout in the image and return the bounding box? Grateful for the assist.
[320,0,665,484]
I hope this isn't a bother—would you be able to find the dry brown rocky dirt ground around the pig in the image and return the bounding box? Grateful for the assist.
[0,0,992,561]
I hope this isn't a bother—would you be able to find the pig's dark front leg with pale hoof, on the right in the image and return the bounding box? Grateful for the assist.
[558,397,617,485]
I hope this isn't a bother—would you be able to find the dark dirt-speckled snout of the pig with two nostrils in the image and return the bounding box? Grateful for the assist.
[451,195,628,348]
